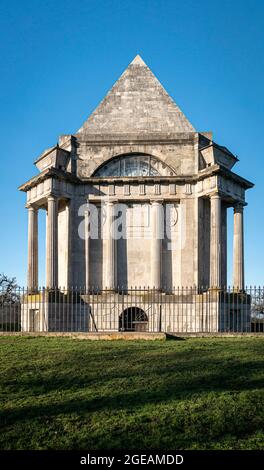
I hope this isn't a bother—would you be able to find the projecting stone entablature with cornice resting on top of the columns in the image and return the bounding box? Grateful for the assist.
[19,160,253,204]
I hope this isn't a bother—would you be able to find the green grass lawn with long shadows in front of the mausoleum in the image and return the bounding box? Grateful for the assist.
[0,337,264,450]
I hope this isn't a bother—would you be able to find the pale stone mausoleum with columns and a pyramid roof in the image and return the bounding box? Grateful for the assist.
[20,56,253,331]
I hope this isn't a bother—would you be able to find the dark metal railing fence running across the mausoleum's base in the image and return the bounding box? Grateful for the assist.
[0,286,264,333]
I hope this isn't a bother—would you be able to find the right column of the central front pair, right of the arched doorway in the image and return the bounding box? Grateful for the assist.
[150,201,164,289]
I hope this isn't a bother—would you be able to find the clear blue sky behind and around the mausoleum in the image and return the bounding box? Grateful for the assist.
[0,0,264,284]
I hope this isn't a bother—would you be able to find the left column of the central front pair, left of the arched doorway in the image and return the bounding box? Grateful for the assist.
[105,201,115,289]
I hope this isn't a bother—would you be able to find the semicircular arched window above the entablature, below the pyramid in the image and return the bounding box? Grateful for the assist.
[93,153,175,177]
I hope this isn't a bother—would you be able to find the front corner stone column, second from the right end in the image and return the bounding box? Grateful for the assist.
[210,194,221,288]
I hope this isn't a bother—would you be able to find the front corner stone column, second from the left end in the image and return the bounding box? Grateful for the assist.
[46,196,58,288]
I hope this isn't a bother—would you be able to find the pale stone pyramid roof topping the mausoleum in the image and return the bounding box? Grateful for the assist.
[78,55,195,135]
